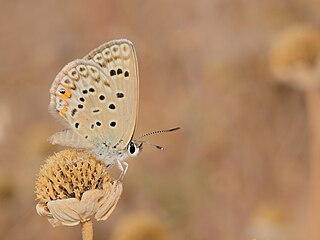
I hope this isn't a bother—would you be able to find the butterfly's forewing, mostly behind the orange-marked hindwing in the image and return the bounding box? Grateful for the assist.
[84,39,138,149]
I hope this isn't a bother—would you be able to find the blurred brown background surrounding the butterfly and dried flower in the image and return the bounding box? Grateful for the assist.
[0,0,320,240]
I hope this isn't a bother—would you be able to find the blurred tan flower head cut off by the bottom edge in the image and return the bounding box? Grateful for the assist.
[112,212,170,240]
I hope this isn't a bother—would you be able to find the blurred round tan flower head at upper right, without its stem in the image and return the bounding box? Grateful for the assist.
[270,25,320,90]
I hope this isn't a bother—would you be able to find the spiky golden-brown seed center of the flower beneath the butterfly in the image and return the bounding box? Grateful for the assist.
[35,150,113,203]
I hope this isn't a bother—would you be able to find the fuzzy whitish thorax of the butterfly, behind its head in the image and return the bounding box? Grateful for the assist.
[92,144,129,164]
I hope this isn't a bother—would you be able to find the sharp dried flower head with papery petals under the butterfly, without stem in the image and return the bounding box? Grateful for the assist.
[35,150,122,226]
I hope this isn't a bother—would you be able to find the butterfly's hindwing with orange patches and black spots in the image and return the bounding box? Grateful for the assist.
[50,60,119,146]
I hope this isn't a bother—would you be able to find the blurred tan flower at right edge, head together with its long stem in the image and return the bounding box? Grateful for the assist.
[270,22,320,240]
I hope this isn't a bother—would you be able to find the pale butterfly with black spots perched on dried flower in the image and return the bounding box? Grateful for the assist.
[49,39,178,178]
